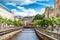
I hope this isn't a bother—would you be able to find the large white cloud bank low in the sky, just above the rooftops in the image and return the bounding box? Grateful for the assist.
[11,7,45,16]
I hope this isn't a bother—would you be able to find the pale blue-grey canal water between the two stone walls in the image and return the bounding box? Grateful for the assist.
[11,29,39,40]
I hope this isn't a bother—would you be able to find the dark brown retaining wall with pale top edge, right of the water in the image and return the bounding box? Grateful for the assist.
[35,29,58,40]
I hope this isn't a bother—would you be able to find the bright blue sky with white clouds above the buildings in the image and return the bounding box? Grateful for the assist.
[0,0,54,16]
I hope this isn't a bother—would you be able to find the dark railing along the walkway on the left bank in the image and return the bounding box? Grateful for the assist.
[0,27,22,36]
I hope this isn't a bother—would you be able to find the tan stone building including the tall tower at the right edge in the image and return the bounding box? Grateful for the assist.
[45,0,60,17]
